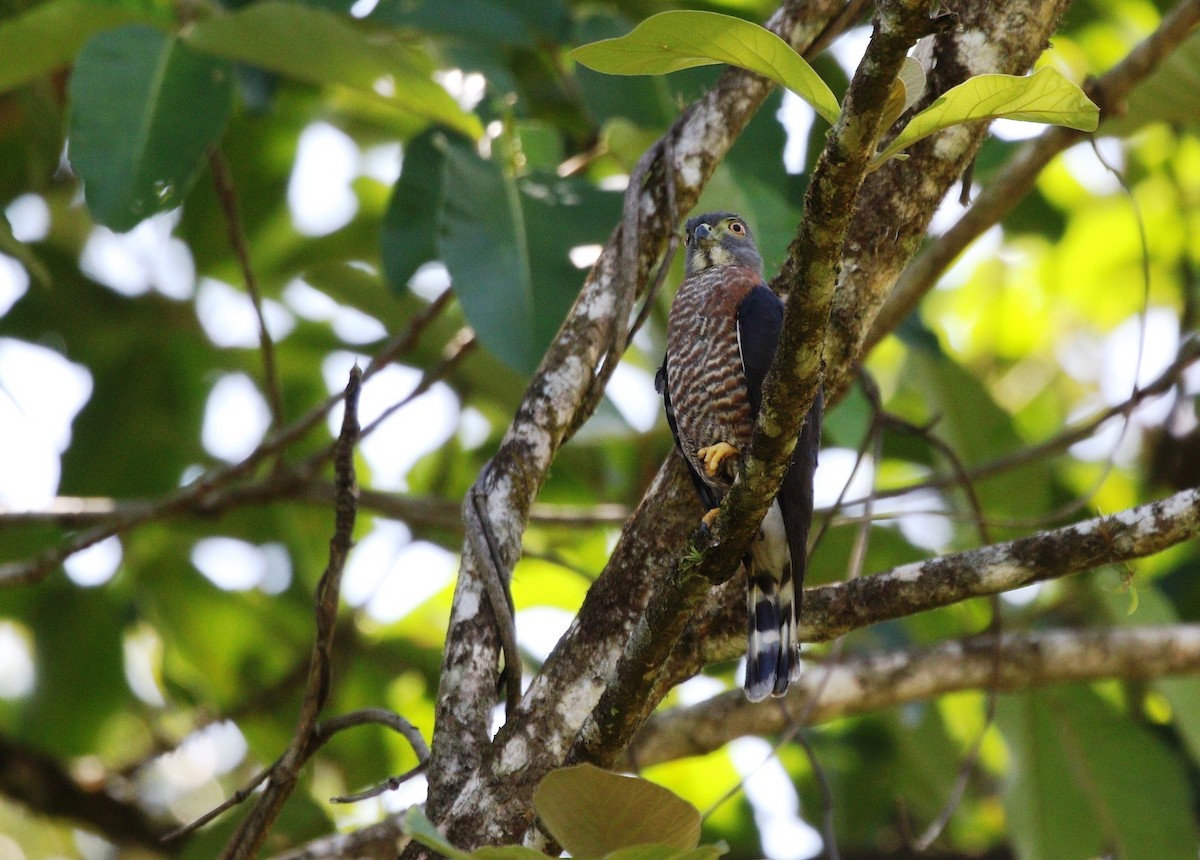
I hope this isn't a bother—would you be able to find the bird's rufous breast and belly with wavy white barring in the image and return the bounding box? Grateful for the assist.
[667,266,761,487]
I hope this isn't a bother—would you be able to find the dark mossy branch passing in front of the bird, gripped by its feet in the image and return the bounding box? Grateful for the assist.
[570,1,929,764]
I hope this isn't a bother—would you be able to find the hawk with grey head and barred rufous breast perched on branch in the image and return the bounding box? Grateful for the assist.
[655,212,823,702]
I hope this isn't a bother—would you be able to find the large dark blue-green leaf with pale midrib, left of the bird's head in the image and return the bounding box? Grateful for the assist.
[427,134,620,373]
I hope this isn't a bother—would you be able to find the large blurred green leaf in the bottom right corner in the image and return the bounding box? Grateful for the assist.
[997,687,1196,860]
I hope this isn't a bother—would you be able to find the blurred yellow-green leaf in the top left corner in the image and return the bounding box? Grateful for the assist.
[0,0,152,92]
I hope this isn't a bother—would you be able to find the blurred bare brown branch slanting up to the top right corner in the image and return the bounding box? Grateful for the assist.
[863,0,1200,351]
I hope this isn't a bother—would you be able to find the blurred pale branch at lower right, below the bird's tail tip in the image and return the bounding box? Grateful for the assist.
[625,624,1200,768]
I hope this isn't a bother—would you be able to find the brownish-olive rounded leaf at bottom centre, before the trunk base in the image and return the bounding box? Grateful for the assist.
[533,764,700,858]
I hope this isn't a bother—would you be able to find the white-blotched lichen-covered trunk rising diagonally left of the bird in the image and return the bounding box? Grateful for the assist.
[427,0,854,847]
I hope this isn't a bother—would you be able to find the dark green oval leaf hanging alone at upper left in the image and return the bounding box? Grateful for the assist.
[70,24,233,230]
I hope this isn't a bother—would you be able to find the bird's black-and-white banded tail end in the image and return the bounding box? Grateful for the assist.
[745,559,800,702]
